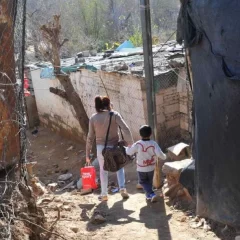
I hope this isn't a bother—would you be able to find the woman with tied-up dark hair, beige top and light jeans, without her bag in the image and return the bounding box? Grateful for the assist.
[86,96,133,201]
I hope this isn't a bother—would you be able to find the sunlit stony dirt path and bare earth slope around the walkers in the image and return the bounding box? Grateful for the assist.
[28,128,219,240]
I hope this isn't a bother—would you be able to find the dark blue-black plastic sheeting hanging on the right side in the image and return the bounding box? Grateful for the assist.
[179,0,240,226]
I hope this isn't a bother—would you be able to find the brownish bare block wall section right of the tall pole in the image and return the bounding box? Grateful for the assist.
[156,68,192,148]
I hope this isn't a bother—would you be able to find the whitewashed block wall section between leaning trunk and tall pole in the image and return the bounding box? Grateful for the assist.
[71,69,146,139]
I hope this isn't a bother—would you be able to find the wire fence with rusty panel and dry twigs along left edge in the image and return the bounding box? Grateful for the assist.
[0,0,27,240]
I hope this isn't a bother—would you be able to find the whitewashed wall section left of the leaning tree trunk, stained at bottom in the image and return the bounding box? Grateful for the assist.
[32,70,84,141]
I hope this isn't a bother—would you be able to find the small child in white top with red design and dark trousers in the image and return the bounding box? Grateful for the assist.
[126,125,166,202]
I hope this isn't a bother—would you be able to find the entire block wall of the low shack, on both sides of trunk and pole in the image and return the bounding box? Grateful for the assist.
[32,69,189,144]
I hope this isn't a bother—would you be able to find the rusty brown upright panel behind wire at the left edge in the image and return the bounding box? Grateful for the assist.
[0,0,20,170]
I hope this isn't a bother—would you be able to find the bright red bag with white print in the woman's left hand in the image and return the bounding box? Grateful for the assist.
[81,166,97,189]
